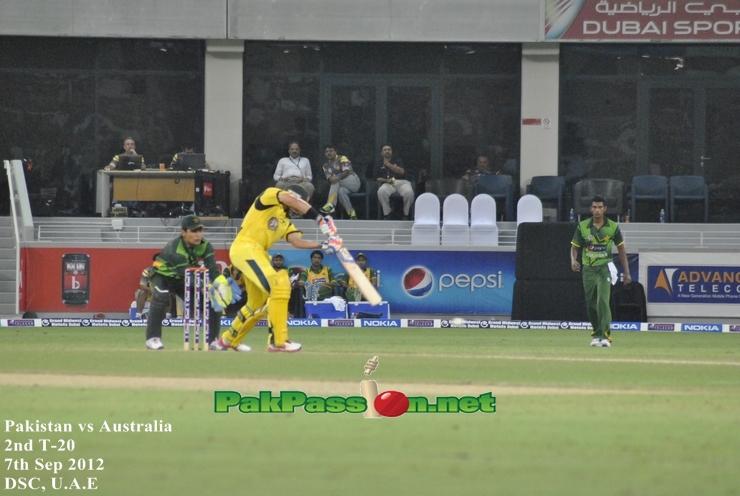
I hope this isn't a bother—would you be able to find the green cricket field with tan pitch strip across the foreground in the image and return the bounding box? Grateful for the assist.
[0,327,740,496]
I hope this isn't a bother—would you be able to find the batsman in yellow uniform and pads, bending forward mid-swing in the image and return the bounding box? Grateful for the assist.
[211,185,342,352]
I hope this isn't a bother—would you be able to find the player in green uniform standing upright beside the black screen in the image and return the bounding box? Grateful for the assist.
[570,195,632,348]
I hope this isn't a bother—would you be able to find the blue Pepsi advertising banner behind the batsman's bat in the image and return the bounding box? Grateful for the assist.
[283,250,516,315]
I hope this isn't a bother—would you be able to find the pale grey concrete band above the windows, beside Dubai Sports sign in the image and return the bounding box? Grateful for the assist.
[0,0,542,42]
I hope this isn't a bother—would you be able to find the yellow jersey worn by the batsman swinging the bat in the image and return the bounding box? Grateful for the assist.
[234,188,300,250]
